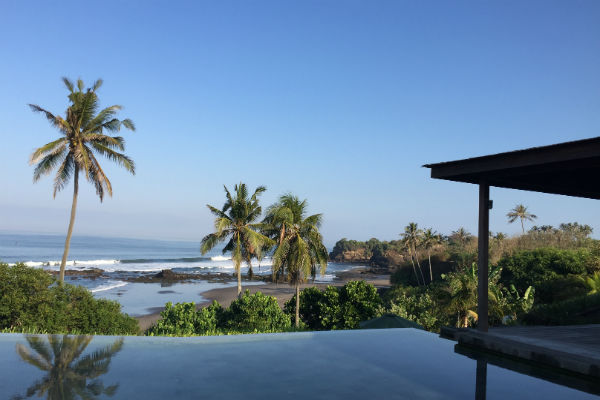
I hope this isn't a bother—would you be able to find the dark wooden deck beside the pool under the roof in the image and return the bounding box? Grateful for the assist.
[441,325,600,378]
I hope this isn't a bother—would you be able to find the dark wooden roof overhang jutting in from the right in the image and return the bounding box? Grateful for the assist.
[424,137,600,199]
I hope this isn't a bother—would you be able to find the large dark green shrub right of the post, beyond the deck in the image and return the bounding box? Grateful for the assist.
[498,248,598,304]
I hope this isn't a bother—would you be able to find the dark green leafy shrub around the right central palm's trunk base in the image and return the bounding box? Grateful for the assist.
[284,281,381,330]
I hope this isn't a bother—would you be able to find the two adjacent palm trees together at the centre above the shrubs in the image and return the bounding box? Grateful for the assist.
[200,183,327,326]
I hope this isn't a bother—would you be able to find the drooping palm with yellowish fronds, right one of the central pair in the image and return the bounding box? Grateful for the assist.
[265,194,327,327]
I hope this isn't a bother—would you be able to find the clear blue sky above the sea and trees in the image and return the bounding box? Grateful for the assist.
[0,1,600,245]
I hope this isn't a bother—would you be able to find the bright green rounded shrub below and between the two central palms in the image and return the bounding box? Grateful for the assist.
[222,290,291,332]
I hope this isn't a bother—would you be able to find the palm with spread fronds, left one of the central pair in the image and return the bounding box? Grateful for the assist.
[200,183,271,298]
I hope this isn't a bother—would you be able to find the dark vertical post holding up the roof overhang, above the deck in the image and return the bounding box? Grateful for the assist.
[477,182,490,332]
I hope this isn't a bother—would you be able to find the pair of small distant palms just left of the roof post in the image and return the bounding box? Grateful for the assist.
[400,222,445,285]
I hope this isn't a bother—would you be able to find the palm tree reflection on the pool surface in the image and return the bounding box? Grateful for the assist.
[14,335,123,400]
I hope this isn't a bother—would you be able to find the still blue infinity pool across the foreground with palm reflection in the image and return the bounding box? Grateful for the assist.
[0,329,598,400]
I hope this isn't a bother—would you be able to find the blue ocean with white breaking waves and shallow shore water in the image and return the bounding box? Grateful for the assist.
[0,233,358,315]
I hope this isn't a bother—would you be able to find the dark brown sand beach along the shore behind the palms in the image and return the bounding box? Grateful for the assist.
[135,268,390,332]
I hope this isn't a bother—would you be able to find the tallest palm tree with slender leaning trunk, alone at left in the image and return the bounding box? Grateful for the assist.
[29,78,135,283]
